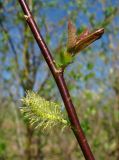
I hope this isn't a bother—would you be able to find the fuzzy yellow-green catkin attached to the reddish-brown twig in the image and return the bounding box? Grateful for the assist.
[21,91,70,130]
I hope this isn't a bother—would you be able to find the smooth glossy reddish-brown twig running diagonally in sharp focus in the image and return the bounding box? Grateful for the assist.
[19,0,99,160]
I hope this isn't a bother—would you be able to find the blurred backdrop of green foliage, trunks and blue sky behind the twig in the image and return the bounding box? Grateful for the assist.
[0,0,119,160]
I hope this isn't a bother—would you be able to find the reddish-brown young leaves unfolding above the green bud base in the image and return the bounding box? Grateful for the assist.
[67,21,104,55]
